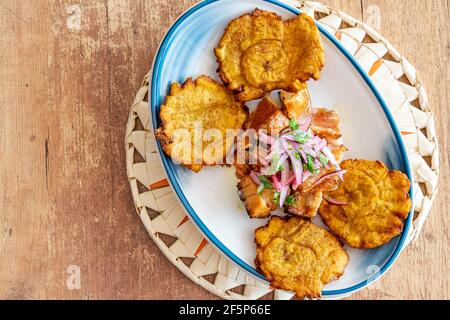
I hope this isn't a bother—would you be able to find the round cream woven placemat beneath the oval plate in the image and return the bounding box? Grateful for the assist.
[125,1,439,299]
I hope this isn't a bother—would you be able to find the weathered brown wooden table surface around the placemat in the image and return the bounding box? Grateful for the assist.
[0,0,450,299]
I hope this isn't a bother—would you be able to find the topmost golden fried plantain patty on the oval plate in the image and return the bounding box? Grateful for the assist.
[215,9,325,101]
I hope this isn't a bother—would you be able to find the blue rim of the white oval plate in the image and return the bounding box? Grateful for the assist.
[149,0,413,296]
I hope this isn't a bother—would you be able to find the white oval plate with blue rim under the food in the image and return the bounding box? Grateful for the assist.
[150,0,412,296]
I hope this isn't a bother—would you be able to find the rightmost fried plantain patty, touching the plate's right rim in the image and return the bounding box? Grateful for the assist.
[319,160,411,249]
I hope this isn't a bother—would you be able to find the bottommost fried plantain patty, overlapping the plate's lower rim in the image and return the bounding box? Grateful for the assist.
[255,216,348,299]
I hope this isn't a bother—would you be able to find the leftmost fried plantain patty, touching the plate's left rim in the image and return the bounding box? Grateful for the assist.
[156,76,248,172]
